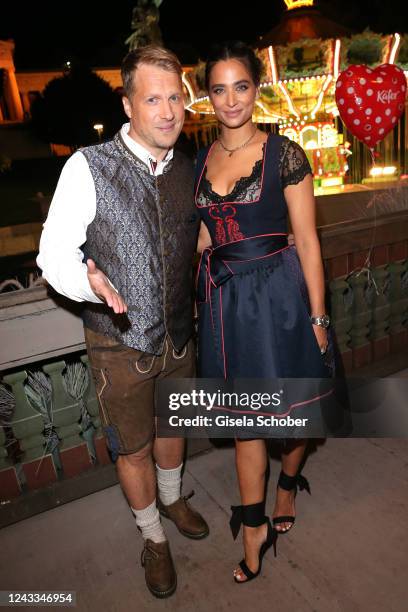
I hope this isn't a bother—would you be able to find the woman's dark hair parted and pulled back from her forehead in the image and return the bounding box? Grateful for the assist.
[205,40,263,91]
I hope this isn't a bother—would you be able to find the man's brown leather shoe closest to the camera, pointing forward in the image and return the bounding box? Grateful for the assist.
[141,540,177,599]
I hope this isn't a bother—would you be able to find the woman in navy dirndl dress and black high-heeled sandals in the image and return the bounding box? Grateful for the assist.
[195,42,334,582]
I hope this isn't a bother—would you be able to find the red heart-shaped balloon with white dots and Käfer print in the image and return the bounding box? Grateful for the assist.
[336,64,407,149]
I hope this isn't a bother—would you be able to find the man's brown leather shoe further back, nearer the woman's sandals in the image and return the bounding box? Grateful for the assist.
[157,491,210,540]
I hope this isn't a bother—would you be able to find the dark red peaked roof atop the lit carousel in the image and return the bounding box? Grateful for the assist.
[258,6,352,49]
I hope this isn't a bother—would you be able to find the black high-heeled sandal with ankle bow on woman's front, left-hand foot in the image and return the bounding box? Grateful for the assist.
[230,501,278,584]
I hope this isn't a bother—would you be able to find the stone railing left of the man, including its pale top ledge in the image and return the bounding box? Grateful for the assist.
[0,286,111,518]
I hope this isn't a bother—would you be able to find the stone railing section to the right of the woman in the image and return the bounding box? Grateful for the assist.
[317,179,408,376]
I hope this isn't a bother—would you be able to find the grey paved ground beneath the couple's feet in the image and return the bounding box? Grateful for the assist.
[0,439,408,612]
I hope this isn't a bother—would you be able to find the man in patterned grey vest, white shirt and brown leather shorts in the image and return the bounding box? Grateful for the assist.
[37,46,208,597]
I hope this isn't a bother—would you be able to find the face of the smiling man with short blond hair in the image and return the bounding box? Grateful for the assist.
[123,64,184,159]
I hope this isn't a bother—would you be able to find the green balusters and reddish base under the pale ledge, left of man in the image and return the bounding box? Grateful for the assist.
[0,354,110,501]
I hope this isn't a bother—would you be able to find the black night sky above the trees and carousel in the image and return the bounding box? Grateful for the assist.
[0,0,408,70]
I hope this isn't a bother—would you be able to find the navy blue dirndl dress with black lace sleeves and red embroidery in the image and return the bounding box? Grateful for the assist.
[195,134,333,379]
